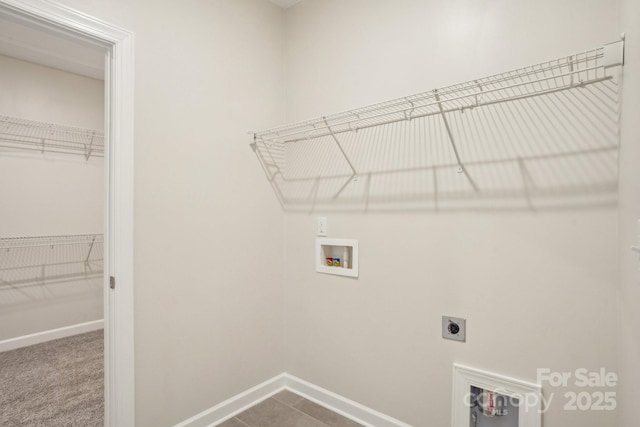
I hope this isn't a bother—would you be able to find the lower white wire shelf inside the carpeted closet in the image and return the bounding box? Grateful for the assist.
[0,234,104,286]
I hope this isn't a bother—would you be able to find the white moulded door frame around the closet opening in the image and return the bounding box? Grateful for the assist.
[0,0,135,427]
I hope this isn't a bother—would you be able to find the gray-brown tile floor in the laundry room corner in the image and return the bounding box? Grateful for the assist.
[217,390,362,427]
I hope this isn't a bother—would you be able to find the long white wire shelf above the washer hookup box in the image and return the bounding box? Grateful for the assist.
[250,40,624,194]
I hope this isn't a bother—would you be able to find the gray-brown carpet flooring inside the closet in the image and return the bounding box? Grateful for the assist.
[0,331,104,427]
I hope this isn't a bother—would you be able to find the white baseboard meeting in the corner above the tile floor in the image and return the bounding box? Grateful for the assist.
[174,373,411,427]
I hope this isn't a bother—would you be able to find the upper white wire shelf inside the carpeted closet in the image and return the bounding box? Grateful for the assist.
[0,115,104,160]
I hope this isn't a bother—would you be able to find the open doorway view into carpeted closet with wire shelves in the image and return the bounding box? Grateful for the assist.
[0,39,105,427]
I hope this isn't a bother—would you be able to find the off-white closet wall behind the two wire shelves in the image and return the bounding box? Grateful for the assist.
[0,56,104,340]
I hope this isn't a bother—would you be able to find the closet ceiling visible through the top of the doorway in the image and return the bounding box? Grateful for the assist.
[0,14,105,80]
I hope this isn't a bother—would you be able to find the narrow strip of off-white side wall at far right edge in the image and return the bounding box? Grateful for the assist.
[618,0,640,426]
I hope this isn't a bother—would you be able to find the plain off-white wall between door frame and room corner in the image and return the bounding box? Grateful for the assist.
[40,0,285,426]
